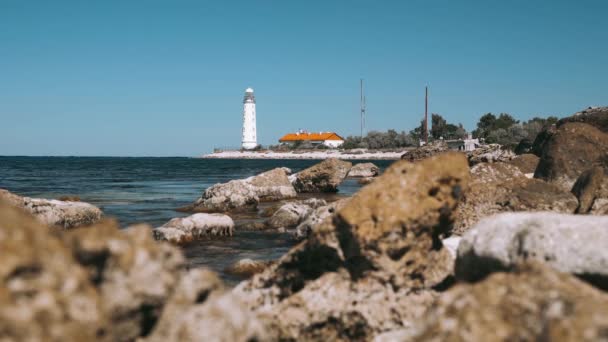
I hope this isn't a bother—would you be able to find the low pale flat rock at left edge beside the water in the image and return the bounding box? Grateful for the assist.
[0,189,102,228]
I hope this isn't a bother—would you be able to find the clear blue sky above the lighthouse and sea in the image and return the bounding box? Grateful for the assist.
[0,0,608,156]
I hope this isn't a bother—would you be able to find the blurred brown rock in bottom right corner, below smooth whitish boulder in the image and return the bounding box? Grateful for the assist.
[408,265,608,341]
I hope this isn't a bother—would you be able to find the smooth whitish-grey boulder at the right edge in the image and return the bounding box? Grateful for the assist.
[456,212,608,288]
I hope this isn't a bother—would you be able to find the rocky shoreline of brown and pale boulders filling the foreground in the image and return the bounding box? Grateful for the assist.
[0,108,608,341]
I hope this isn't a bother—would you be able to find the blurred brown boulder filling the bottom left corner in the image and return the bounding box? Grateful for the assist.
[0,200,110,341]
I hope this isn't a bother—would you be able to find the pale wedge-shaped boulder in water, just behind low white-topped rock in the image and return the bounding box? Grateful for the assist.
[185,168,297,212]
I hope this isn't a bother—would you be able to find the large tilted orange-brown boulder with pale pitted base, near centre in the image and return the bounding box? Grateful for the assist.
[234,153,469,341]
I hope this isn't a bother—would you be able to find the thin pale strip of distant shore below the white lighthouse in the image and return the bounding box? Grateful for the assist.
[199,150,406,160]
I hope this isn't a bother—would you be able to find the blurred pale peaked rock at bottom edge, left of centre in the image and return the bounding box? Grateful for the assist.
[145,269,267,342]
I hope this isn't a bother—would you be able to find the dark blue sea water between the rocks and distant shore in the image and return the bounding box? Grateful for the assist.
[0,156,392,283]
